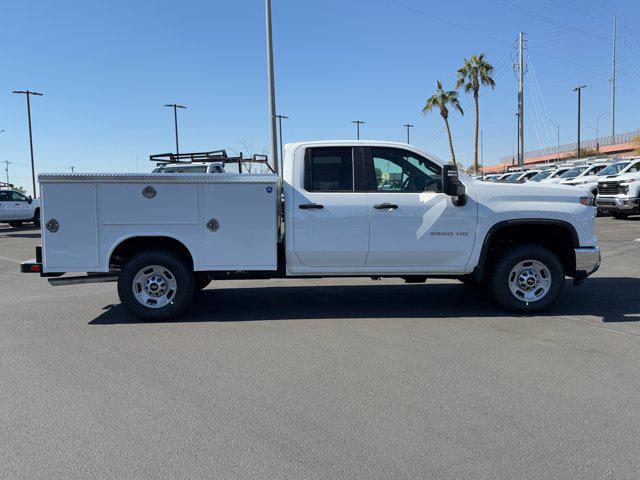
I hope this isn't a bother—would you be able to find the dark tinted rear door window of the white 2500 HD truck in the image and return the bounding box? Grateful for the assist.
[304,147,354,192]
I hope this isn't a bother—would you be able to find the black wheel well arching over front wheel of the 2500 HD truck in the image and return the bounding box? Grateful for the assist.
[476,222,578,279]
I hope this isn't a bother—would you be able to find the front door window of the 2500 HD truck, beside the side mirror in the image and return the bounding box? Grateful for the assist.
[371,147,442,193]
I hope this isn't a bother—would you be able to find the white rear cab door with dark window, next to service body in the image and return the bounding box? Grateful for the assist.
[292,146,369,273]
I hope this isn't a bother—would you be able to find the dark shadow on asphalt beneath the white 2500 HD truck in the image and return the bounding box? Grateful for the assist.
[89,277,640,325]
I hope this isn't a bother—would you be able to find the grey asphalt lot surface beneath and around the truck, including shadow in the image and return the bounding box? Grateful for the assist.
[0,217,640,480]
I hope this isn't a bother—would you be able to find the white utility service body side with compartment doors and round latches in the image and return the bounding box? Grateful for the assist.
[38,173,279,273]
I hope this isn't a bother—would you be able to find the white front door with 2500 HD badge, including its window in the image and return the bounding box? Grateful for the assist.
[365,147,476,272]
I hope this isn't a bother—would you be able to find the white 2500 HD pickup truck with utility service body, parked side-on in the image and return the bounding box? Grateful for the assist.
[21,141,600,320]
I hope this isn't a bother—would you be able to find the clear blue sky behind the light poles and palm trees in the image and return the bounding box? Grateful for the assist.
[0,0,640,194]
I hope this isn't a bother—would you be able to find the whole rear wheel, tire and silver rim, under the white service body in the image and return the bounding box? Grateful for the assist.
[118,250,196,320]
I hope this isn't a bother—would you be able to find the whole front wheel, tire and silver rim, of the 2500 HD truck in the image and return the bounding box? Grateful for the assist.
[489,244,565,313]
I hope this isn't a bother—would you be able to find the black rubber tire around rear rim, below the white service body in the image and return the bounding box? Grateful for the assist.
[118,250,196,321]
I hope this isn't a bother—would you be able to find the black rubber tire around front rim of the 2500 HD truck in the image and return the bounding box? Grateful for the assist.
[489,244,565,313]
